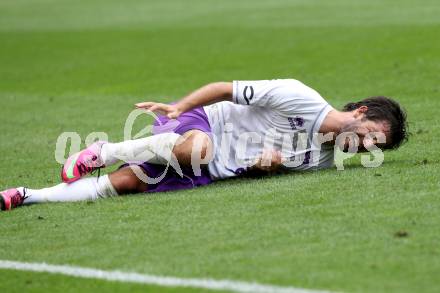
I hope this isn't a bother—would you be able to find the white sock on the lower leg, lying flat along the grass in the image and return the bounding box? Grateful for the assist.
[19,175,118,204]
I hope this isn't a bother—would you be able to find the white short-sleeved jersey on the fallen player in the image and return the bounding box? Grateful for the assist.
[204,79,333,179]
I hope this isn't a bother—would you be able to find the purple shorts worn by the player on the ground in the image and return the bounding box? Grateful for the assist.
[121,107,212,192]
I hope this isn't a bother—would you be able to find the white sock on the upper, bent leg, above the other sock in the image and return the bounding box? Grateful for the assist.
[101,133,180,167]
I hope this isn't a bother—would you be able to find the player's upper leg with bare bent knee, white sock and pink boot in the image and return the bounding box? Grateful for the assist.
[62,130,212,183]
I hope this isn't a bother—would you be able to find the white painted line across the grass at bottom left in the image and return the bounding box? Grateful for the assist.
[0,260,336,293]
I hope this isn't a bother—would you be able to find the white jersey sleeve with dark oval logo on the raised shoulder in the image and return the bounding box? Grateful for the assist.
[232,79,322,114]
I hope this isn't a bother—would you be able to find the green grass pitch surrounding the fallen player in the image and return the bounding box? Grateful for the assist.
[0,0,440,292]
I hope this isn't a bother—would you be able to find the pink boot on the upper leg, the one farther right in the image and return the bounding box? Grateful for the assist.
[61,141,106,183]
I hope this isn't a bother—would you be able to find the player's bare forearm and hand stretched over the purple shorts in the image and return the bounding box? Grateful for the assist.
[135,82,232,119]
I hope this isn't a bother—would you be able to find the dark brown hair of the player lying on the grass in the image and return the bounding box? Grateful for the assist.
[343,96,408,149]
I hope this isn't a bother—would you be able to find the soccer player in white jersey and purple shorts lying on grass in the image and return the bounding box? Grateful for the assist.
[0,79,407,210]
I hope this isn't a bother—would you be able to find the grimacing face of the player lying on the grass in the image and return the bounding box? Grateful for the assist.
[342,114,389,152]
